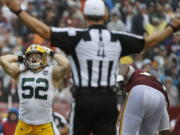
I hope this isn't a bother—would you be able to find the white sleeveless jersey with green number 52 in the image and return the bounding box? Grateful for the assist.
[18,65,56,125]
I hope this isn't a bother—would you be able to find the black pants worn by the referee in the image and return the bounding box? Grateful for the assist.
[70,88,118,135]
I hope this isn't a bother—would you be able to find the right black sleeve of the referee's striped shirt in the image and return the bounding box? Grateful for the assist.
[118,32,145,56]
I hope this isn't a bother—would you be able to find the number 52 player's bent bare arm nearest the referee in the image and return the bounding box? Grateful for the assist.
[52,54,70,86]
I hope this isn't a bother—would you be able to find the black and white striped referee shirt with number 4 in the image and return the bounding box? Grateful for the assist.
[51,25,145,87]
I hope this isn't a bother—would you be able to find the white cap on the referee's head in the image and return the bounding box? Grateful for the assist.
[84,0,105,16]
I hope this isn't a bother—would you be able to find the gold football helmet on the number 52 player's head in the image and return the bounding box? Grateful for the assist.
[25,44,47,71]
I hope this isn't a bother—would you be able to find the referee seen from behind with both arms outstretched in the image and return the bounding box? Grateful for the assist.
[3,0,180,135]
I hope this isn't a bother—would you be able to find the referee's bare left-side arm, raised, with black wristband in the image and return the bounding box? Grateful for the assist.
[3,0,51,39]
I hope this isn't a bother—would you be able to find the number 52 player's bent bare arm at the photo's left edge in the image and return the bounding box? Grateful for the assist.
[0,55,20,80]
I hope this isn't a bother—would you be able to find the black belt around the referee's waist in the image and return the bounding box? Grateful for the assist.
[73,86,114,94]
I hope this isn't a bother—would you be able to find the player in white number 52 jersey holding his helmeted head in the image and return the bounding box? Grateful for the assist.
[0,44,69,135]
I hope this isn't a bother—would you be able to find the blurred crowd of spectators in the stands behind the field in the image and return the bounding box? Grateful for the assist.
[0,0,180,134]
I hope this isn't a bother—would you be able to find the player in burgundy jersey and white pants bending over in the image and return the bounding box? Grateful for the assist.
[116,65,169,135]
